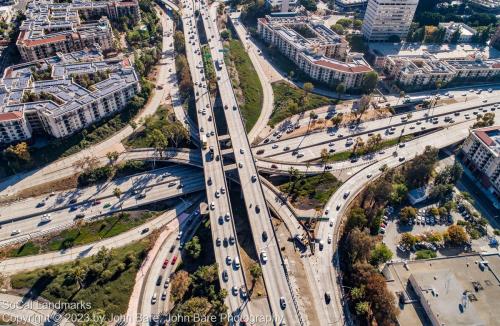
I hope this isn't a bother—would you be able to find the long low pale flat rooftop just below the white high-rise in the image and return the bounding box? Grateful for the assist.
[369,42,500,59]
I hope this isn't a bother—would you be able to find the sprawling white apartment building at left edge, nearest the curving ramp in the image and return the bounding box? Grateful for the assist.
[0,50,140,144]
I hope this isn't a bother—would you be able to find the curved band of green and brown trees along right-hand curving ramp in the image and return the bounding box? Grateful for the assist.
[341,147,437,325]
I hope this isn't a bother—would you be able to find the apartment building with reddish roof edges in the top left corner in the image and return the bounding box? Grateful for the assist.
[16,0,140,61]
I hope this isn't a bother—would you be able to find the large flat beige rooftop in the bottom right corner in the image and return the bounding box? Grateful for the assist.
[383,254,500,326]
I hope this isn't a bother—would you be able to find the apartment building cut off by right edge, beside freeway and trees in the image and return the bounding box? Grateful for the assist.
[462,126,500,198]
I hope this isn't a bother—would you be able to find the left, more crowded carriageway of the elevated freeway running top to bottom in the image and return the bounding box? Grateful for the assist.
[182,0,250,318]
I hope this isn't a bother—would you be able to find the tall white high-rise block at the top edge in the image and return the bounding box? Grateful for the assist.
[361,0,418,42]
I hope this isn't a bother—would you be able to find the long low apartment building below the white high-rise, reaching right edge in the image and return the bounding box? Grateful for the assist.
[377,53,500,90]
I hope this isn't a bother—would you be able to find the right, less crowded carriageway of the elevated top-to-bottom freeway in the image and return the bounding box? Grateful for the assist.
[201,2,303,325]
